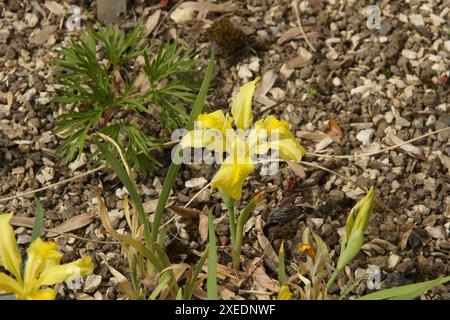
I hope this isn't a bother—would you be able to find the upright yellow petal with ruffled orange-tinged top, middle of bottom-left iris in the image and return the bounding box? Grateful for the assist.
[24,238,62,291]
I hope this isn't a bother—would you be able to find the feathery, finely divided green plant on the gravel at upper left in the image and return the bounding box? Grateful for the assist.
[54,25,198,174]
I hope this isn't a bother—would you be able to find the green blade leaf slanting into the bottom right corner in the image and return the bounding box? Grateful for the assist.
[357,276,450,300]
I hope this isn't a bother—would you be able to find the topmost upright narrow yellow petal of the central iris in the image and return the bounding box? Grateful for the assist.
[231,77,260,131]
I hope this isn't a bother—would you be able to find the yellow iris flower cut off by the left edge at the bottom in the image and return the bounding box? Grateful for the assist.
[0,214,94,300]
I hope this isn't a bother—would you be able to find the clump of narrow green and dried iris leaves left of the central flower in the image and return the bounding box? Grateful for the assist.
[89,52,217,300]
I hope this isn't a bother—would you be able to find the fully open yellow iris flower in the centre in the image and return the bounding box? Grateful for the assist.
[180,77,306,200]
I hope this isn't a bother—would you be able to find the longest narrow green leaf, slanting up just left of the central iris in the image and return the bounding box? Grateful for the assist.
[152,50,215,241]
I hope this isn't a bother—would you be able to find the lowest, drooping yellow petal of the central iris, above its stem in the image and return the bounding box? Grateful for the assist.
[211,160,255,200]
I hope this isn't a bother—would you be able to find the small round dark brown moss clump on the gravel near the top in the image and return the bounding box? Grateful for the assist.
[208,18,247,55]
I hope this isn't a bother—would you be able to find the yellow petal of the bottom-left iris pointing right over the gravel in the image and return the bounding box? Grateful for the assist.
[38,256,94,286]
